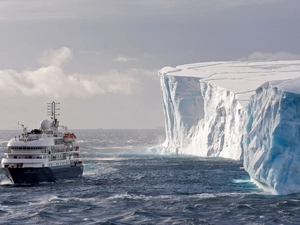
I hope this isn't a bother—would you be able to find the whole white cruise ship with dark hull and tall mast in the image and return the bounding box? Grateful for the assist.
[1,102,83,184]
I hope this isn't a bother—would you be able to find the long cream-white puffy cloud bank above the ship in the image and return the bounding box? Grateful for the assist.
[0,47,139,99]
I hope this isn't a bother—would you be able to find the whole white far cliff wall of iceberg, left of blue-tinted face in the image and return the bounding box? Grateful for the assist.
[161,75,242,159]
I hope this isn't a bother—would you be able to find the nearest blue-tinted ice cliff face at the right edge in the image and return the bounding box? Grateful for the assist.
[244,79,300,194]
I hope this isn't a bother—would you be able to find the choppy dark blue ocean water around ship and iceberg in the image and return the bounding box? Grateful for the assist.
[0,130,300,224]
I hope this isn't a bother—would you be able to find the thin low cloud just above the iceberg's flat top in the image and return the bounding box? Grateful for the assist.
[239,52,300,61]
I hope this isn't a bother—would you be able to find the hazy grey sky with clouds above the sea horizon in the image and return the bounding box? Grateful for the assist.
[0,0,300,129]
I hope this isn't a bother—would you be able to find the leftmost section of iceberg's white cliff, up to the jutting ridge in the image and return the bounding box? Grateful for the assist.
[160,76,204,154]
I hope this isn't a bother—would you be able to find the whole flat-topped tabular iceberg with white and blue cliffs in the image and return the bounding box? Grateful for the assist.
[159,61,300,194]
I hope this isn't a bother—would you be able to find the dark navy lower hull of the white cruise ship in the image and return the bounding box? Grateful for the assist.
[1,165,83,184]
